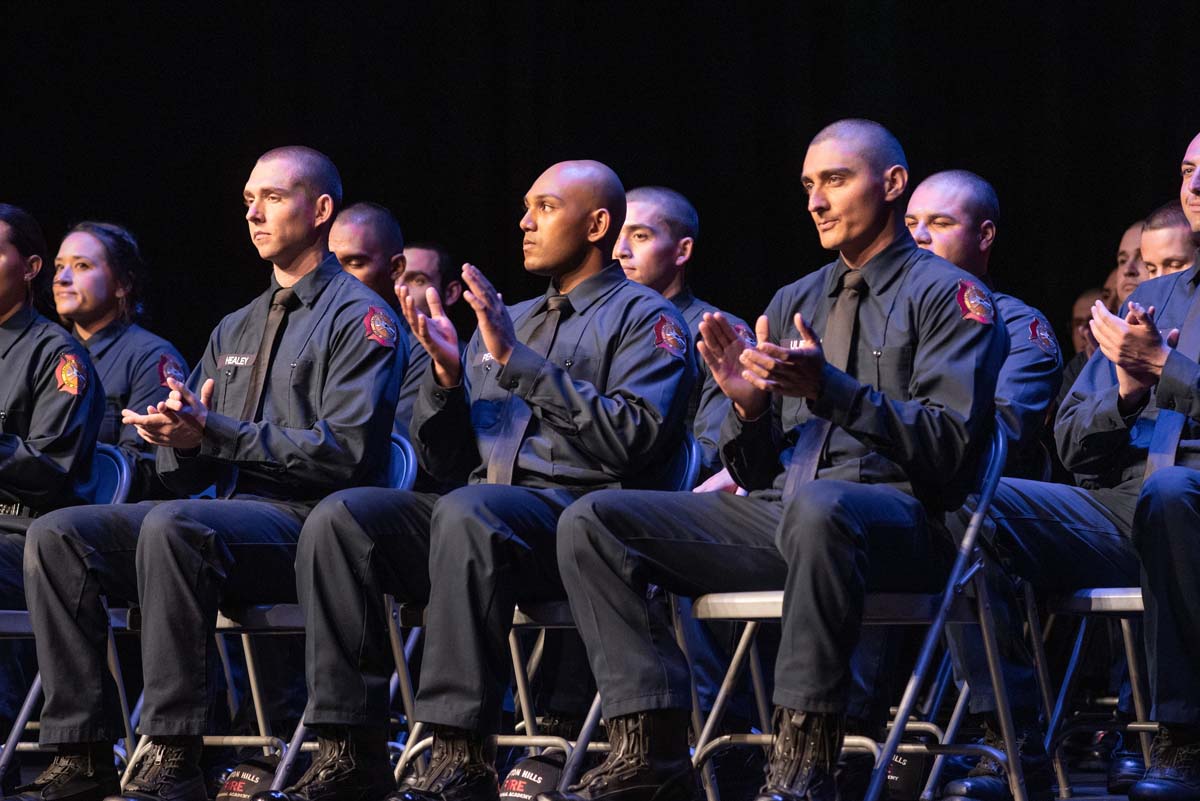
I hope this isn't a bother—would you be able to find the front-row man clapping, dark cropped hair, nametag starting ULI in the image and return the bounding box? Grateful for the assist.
[542,120,1007,801]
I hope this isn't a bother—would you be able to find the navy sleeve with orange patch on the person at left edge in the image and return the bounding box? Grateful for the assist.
[0,348,104,510]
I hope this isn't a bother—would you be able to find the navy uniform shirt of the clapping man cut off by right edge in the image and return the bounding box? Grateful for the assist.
[1055,265,1200,487]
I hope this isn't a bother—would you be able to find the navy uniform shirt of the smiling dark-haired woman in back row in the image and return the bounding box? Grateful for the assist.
[73,320,187,500]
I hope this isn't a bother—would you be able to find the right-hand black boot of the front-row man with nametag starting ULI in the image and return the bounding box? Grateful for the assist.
[755,706,846,801]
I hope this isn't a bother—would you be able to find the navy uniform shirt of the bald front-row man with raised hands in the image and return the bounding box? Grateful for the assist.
[412,263,696,489]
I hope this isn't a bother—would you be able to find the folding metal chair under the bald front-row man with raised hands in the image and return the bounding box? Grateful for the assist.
[394,432,703,789]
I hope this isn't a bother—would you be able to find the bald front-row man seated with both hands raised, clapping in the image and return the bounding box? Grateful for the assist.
[259,161,695,801]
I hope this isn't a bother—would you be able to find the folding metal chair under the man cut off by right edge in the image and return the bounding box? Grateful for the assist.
[1031,586,1158,799]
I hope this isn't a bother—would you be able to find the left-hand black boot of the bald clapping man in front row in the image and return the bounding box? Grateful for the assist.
[252,725,396,801]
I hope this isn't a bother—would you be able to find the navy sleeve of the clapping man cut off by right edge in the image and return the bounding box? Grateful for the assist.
[1055,349,1138,475]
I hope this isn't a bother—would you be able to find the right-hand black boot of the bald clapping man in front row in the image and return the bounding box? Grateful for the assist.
[388,725,500,801]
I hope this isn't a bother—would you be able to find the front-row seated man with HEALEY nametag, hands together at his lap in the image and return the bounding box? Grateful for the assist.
[10,146,407,801]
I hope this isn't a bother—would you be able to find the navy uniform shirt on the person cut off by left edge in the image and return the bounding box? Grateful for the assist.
[0,307,104,513]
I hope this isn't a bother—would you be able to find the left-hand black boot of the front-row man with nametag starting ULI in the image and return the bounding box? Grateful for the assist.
[538,709,700,801]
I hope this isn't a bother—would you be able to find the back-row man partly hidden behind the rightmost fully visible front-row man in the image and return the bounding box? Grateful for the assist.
[902,170,1062,797]
